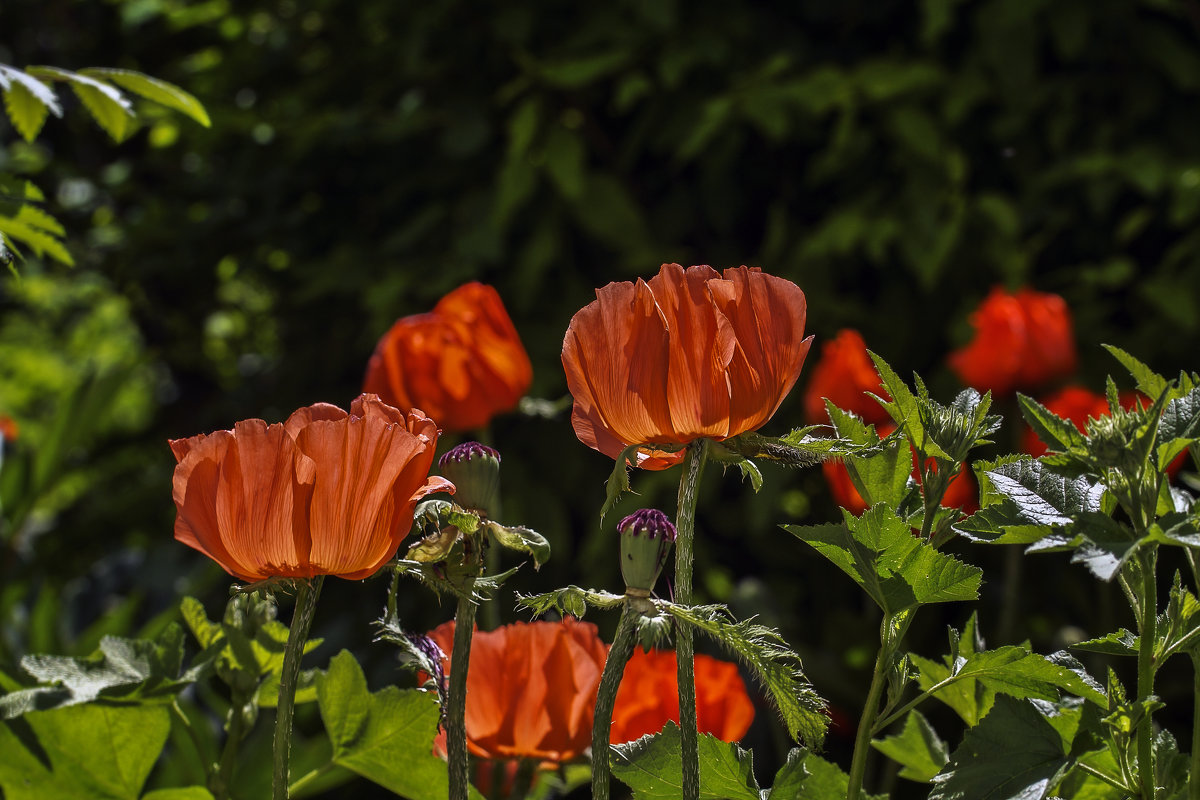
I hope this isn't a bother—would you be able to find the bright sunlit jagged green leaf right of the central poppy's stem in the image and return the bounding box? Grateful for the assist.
[784,505,983,615]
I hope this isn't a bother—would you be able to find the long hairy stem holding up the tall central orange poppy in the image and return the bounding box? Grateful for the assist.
[674,439,708,800]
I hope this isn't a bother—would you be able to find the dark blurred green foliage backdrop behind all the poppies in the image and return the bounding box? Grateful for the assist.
[0,0,1200,796]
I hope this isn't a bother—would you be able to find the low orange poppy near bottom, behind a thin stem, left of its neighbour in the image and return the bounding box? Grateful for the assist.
[430,619,608,762]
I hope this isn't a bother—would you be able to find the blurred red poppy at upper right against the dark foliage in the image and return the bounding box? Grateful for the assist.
[949,287,1075,395]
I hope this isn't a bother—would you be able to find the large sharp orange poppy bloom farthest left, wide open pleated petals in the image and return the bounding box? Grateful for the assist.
[170,395,454,581]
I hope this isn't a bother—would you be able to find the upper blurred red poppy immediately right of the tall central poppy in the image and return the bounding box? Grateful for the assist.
[804,329,892,425]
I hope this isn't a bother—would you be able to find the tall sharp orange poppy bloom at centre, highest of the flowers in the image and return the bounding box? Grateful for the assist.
[563,264,812,469]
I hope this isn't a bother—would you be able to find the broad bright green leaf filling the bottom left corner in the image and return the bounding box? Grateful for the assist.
[0,703,170,800]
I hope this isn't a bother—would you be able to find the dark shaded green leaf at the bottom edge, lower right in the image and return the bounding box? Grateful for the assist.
[929,696,1099,800]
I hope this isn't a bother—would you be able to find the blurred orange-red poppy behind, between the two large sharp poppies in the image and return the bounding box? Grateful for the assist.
[362,283,533,431]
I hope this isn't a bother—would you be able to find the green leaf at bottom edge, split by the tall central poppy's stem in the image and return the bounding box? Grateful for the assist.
[611,722,761,800]
